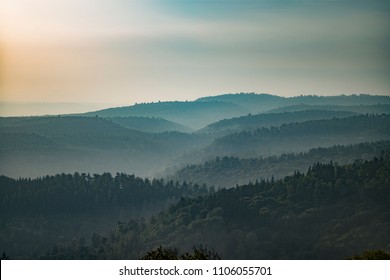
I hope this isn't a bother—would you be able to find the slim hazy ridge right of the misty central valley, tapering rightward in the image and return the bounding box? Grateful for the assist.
[198,110,357,134]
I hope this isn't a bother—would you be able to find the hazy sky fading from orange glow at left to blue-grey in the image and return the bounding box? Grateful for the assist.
[0,0,390,114]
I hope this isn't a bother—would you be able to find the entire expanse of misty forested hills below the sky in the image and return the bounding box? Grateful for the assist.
[0,93,390,259]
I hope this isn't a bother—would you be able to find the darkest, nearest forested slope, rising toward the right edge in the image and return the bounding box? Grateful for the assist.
[44,152,390,259]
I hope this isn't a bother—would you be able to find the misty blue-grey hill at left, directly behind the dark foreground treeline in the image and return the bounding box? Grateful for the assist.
[0,116,203,178]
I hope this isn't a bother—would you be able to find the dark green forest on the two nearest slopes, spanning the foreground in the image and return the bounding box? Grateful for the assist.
[0,150,390,259]
